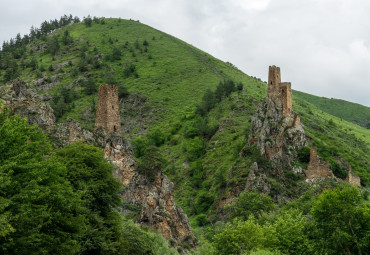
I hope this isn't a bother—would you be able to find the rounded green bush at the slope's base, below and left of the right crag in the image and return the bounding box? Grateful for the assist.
[225,191,275,220]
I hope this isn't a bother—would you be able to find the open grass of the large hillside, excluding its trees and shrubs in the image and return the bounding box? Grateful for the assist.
[1,19,370,221]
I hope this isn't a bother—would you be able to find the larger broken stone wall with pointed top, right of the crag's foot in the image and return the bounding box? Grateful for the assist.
[306,147,334,180]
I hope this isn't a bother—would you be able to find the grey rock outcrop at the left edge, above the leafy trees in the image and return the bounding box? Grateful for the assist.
[0,78,55,131]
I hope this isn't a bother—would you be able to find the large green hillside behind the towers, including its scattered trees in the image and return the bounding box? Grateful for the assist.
[0,16,370,219]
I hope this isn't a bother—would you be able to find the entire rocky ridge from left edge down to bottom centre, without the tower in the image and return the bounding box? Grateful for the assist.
[0,79,196,247]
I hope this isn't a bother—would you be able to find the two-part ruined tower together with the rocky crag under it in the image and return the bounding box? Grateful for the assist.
[249,66,307,171]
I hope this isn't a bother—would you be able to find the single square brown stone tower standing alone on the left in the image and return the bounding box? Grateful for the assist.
[95,84,121,134]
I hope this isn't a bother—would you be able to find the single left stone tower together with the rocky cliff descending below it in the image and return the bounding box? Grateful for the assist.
[95,85,196,248]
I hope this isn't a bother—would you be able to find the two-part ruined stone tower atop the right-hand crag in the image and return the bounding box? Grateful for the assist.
[267,66,292,115]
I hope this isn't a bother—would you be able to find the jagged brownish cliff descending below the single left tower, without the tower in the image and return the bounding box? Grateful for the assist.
[104,134,196,247]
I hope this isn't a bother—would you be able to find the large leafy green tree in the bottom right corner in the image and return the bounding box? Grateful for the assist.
[311,187,370,254]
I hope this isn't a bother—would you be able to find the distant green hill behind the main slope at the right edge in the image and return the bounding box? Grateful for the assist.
[293,91,370,129]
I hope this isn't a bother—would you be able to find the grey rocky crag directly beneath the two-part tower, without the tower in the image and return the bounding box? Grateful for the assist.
[249,97,307,171]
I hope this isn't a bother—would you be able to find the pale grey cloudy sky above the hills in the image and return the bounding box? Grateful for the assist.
[0,0,370,106]
